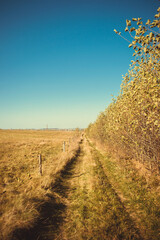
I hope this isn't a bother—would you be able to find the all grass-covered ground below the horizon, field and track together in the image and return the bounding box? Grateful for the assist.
[0,131,160,240]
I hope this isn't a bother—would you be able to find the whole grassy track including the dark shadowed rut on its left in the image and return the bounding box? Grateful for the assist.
[13,137,143,240]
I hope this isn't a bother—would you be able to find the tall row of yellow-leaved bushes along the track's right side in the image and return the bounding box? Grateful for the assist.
[87,8,160,172]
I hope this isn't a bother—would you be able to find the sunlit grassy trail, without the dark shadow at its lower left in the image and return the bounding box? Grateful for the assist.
[55,138,142,240]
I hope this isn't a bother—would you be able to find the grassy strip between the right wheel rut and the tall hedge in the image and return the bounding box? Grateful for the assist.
[88,138,160,240]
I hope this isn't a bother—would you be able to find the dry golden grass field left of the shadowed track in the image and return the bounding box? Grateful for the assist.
[0,130,78,239]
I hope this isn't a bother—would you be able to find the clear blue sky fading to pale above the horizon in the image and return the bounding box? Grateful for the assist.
[0,0,160,128]
